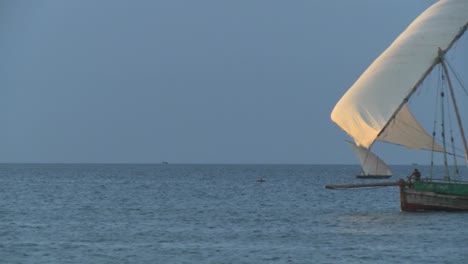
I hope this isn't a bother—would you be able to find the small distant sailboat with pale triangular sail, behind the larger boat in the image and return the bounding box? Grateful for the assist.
[346,140,392,179]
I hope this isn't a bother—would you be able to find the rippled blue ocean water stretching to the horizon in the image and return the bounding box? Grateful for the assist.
[0,164,468,264]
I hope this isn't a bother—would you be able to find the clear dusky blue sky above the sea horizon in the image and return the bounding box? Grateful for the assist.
[0,0,464,164]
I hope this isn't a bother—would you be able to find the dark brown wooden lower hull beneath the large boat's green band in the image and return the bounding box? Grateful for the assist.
[400,184,468,212]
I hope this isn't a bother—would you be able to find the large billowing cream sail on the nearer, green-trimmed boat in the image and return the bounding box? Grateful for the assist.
[331,0,468,149]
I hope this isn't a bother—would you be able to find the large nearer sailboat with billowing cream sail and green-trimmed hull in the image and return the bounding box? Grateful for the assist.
[331,0,468,211]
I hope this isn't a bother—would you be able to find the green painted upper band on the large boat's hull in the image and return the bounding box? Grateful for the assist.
[413,181,468,196]
